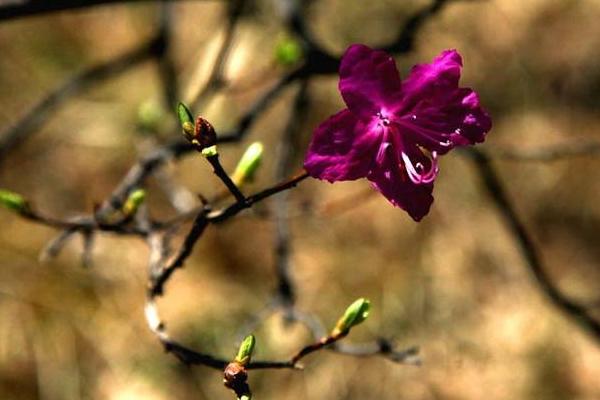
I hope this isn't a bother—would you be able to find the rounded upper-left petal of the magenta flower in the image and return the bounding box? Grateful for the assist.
[339,44,402,120]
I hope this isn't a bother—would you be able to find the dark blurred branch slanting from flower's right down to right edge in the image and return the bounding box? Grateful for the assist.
[468,148,600,342]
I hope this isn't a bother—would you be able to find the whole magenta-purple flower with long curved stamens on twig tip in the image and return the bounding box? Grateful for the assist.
[304,44,492,221]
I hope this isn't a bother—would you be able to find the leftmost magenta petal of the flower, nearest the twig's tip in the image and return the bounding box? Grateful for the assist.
[304,109,381,182]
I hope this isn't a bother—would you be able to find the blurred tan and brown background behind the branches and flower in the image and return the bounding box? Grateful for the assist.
[0,0,600,400]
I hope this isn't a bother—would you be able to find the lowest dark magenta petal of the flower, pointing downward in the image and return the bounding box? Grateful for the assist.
[367,141,433,221]
